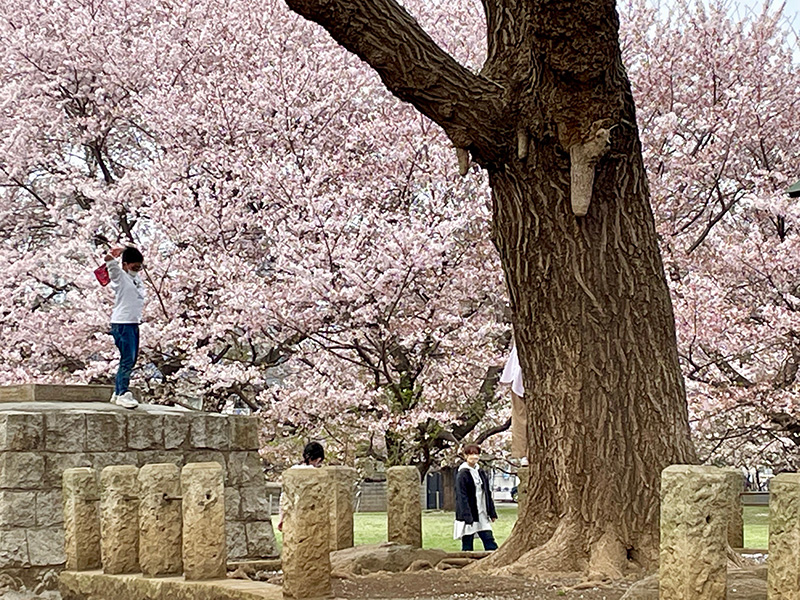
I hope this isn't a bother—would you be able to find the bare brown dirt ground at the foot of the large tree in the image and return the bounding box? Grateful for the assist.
[333,570,630,600]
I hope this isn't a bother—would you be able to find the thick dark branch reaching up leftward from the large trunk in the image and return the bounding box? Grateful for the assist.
[286,0,505,165]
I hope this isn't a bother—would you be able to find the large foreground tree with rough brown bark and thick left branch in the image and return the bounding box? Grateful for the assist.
[287,0,695,577]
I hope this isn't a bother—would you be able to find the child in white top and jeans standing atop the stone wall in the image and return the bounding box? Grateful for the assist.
[105,247,144,408]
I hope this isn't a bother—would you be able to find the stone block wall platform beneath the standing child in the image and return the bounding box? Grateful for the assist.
[0,402,276,571]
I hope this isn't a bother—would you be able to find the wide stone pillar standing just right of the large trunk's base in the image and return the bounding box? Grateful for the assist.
[658,465,728,600]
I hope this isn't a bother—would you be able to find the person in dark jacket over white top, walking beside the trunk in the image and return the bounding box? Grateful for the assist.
[453,444,497,551]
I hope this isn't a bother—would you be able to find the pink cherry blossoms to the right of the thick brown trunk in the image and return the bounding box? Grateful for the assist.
[623,2,800,469]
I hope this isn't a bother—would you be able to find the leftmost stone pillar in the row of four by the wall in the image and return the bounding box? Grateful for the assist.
[61,467,101,571]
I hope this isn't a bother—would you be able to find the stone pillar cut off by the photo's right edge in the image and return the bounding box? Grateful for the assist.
[767,473,800,600]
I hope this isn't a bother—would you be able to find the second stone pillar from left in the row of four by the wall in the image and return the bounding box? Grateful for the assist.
[100,465,139,575]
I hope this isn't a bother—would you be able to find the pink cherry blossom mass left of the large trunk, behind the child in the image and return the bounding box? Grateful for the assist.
[0,0,509,471]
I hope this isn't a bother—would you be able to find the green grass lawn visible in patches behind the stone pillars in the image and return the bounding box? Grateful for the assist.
[272,504,769,551]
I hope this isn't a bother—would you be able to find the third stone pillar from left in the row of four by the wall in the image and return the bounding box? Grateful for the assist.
[139,463,183,577]
